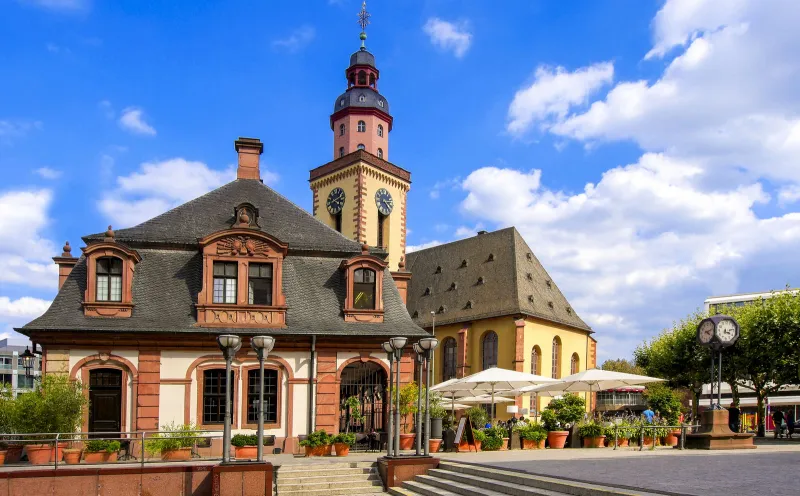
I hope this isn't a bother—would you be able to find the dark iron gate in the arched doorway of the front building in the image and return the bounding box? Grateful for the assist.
[339,362,386,433]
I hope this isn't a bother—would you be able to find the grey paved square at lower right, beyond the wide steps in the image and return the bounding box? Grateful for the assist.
[478,449,800,496]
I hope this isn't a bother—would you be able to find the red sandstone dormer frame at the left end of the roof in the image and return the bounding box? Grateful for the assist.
[82,238,142,318]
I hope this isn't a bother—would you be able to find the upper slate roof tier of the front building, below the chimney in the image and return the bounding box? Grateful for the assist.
[83,179,361,253]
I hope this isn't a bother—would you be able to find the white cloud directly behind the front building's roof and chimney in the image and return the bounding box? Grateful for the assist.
[98,158,278,228]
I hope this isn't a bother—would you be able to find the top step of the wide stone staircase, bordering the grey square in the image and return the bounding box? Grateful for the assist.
[438,460,656,496]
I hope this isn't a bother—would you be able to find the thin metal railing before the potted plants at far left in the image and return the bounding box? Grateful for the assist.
[0,431,222,470]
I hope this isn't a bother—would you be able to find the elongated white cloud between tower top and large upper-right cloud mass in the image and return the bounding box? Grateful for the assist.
[507,62,614,134]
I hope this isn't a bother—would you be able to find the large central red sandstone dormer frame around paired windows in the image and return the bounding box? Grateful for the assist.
[196,227,288,328]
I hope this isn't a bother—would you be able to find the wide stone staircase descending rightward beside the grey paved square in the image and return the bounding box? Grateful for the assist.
[389,460,663,496]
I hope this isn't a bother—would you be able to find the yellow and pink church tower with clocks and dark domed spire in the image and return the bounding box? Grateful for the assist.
[309,2,411,271]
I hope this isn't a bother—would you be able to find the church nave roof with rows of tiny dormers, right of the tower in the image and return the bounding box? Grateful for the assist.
[406,227,591,332]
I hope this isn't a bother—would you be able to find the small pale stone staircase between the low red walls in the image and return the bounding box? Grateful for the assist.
[275,462,384,496]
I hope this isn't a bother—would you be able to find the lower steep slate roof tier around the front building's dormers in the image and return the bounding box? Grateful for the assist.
[23,249,427,336]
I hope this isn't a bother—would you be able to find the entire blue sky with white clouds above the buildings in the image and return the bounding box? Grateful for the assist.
[0,0,800,359]
